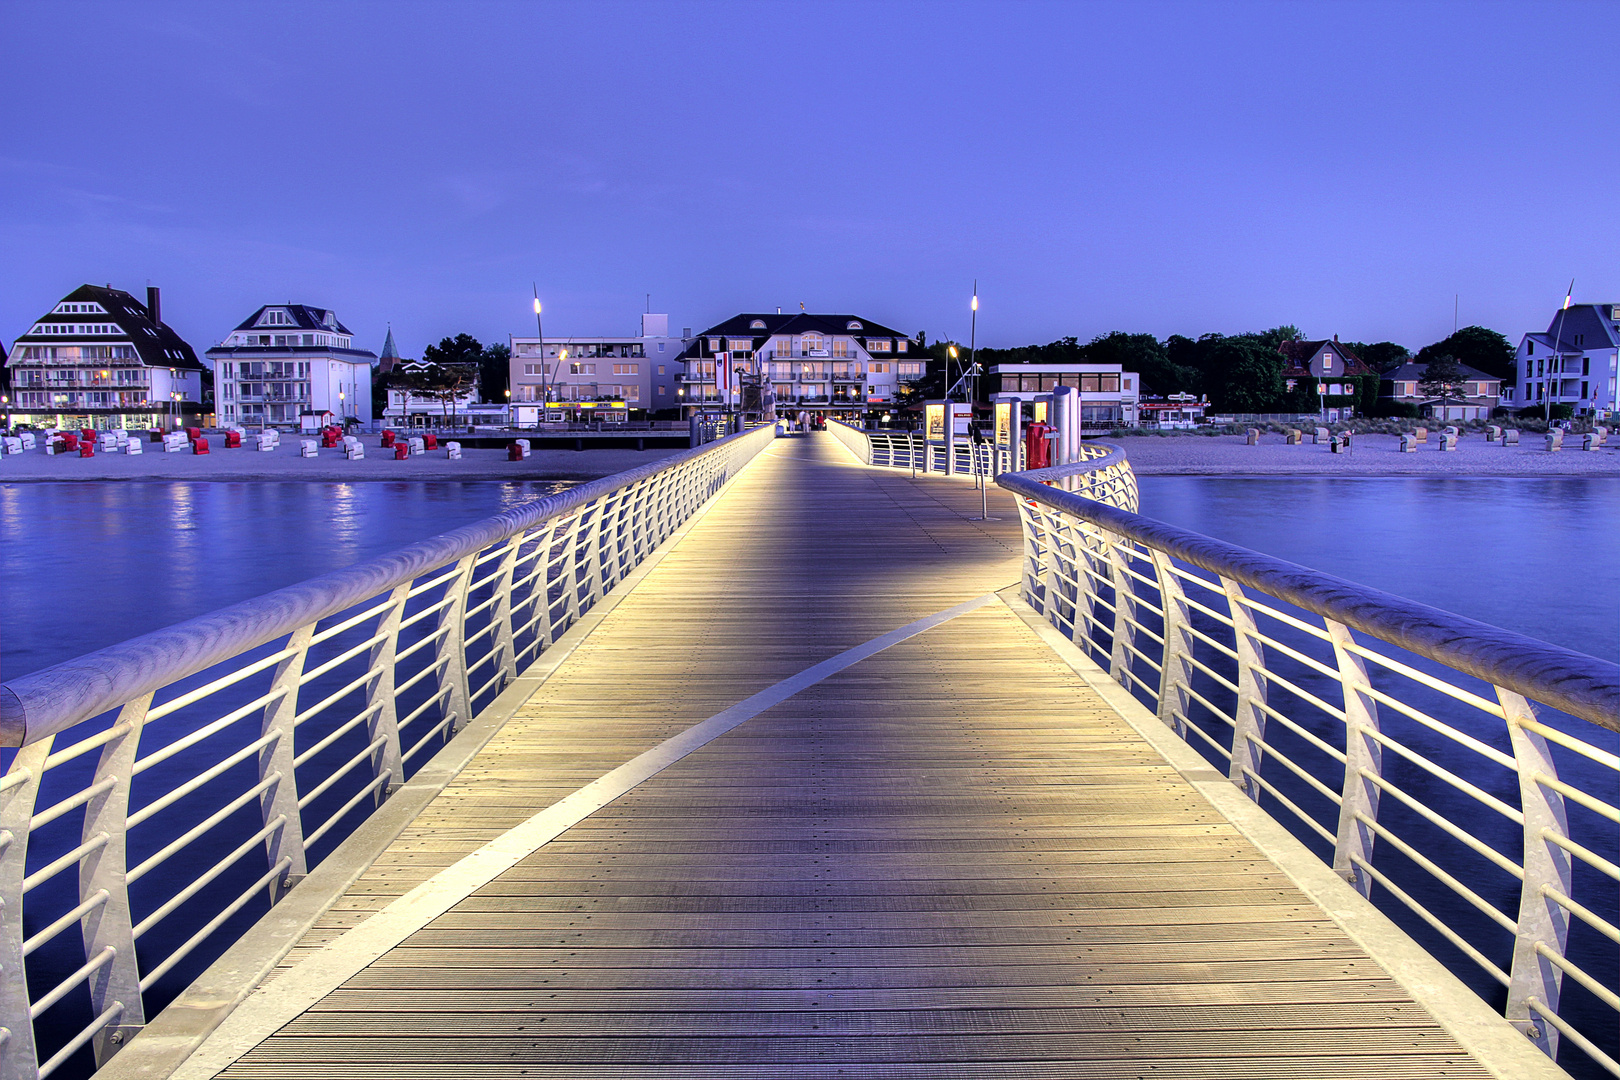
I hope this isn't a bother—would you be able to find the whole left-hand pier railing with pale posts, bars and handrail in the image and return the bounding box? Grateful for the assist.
[0,427,774,1080]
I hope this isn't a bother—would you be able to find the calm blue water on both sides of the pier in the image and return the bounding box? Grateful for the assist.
[0,478,1620,1077]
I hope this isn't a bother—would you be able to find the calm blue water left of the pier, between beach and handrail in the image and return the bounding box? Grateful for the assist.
[0,481,575,678]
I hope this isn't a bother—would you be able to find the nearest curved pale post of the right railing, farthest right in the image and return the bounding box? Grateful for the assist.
[1497,687,1573,1059]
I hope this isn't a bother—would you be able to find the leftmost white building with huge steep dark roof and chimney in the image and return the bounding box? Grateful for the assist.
[5,285,204,429]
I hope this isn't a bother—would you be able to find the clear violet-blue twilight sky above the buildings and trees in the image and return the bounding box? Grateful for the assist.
[0,0,1620,356]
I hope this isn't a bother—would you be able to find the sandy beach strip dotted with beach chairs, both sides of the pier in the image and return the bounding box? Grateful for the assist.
[0,434,1620,483]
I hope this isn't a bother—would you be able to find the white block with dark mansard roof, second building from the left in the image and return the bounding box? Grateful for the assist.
[207,304,377,427]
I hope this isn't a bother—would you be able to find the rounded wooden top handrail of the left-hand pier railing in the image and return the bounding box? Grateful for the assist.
[0,432,771,746]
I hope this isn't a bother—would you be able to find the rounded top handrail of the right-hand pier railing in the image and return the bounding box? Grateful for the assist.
[996,466,1620,732]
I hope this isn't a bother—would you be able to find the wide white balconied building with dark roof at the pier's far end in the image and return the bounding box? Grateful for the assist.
[679,311,925,423]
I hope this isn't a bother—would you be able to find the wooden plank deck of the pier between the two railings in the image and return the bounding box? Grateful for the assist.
[186,437,1490,1080]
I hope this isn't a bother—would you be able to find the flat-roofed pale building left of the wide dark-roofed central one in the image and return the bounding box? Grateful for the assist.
[509,314,684,427]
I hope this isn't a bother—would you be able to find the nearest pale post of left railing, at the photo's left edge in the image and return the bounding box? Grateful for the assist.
[0,737,55,1080]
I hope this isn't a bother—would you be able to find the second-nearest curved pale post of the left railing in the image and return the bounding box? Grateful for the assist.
[79,695,152,1069]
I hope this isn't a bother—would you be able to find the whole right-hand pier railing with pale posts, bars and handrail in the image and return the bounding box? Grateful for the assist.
[996,445,1620,1075]
